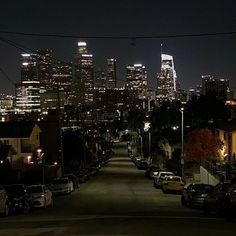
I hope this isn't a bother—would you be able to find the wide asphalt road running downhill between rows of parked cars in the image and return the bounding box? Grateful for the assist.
[0,143,236,236]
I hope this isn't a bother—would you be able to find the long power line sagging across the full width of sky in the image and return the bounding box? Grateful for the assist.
[0,31,236,40]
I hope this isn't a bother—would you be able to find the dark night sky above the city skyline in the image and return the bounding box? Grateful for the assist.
[0,0,236,94]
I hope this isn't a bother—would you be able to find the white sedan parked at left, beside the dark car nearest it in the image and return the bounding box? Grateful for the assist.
[28,184,53,208]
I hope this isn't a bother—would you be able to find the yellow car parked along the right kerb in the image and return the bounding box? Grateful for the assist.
[161,175,185,193]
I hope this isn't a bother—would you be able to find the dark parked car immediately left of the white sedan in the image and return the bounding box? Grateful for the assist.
[4,184,34,213]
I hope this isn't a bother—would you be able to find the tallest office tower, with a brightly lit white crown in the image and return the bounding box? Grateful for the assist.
[73,42,94,105]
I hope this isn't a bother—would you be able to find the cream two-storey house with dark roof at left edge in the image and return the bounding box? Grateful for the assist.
[0,121,41,166]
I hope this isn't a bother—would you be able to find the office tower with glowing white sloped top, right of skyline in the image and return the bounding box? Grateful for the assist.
[157,54,177,103]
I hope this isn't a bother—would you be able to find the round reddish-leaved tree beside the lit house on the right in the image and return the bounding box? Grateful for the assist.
[184,128,222,164]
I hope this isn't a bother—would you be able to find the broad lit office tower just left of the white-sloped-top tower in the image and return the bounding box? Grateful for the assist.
[126,64,147,99]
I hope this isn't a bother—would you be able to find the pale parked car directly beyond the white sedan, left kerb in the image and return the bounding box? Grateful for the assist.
[50,177,74,195]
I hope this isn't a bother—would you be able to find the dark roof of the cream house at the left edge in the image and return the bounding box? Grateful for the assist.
[0,121,39,138]
